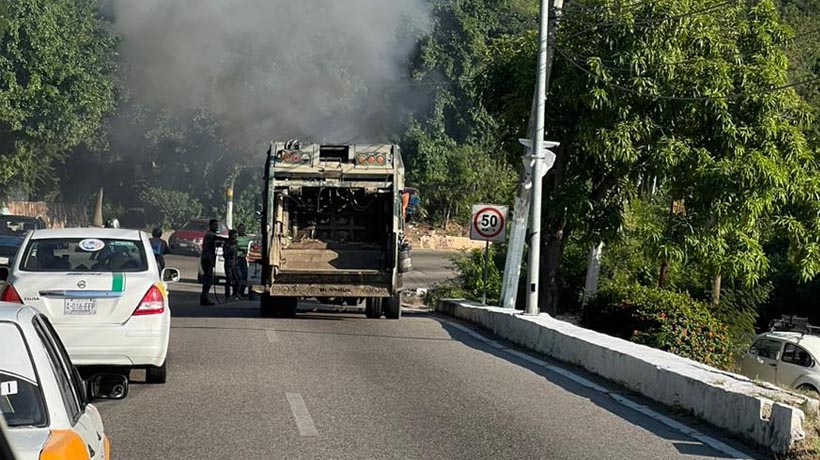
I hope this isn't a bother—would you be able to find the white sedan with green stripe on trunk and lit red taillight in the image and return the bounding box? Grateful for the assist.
[0,228,179,383]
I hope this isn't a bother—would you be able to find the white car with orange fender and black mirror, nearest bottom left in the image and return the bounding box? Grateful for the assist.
[0,303,128,460]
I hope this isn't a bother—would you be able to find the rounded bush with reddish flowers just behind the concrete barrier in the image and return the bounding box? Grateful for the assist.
[582,284,733,369]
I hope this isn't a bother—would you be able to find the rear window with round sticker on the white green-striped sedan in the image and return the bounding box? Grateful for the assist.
[20,238,148,272]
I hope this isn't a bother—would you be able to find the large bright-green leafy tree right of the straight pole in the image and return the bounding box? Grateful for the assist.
[480,0,817,313]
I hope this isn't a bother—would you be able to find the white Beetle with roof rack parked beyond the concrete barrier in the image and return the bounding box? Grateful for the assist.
[741,331,820,392]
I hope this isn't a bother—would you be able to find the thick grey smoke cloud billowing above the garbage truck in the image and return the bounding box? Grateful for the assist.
[112,0,429,152]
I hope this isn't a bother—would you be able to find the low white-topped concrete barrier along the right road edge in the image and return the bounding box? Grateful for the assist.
[437,300,818,453]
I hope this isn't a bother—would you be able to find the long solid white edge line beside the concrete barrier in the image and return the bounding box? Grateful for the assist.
[439,318,754,460]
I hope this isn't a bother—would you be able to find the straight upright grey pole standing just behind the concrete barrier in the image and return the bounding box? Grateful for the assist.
[526,0,550,315]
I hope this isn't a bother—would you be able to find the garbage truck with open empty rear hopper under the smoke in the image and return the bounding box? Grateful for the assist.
[250,140,412,319]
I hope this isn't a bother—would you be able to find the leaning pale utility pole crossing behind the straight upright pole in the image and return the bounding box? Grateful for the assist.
[500,0,564,308]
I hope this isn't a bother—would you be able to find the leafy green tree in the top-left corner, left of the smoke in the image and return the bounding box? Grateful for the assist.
[0,0,116,194]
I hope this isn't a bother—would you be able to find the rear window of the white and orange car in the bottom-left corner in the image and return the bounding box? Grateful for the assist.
[0,322,46,427]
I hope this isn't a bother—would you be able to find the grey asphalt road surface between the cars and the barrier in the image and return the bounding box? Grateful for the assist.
[98,291,768,460]
